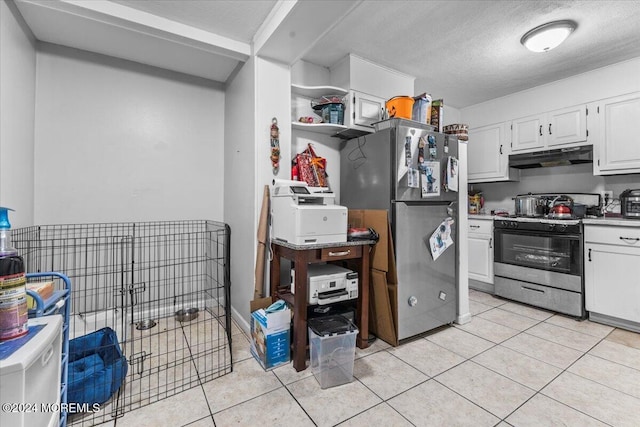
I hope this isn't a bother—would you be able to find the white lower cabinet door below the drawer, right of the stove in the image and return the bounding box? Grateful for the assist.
[584,244,640,322]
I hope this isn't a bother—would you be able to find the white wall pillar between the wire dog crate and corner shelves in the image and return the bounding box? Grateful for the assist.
[224,57,291,331]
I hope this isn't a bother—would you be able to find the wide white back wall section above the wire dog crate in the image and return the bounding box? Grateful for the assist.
[35,43,225,224]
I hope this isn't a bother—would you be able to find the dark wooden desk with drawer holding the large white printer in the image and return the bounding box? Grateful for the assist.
[271,240,376,371]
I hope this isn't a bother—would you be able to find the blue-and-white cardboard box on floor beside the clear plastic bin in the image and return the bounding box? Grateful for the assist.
[251,308,291,370]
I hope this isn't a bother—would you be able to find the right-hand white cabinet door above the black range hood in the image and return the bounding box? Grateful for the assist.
[543,105,587,147]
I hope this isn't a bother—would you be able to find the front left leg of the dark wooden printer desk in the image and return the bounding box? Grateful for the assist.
[293,251,308,372]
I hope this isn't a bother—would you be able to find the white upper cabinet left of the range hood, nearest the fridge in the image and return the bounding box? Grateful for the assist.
[467,122,519,183]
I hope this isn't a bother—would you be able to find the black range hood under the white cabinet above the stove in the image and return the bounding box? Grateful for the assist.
[509,145,593,169]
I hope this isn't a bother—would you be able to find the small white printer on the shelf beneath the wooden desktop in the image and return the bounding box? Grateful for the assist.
[291,264,358,305]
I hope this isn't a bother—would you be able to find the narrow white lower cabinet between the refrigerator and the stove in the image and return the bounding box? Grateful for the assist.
[469,217,494,293]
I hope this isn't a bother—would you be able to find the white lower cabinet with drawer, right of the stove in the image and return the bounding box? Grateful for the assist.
[584,225,640,332]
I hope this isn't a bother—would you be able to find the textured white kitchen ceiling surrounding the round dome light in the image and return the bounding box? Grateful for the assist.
[304,1,640,108]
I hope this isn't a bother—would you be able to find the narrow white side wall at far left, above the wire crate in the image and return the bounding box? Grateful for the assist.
[0,1,36,228]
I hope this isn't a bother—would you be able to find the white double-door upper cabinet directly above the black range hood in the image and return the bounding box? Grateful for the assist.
[511,105,587,152]
